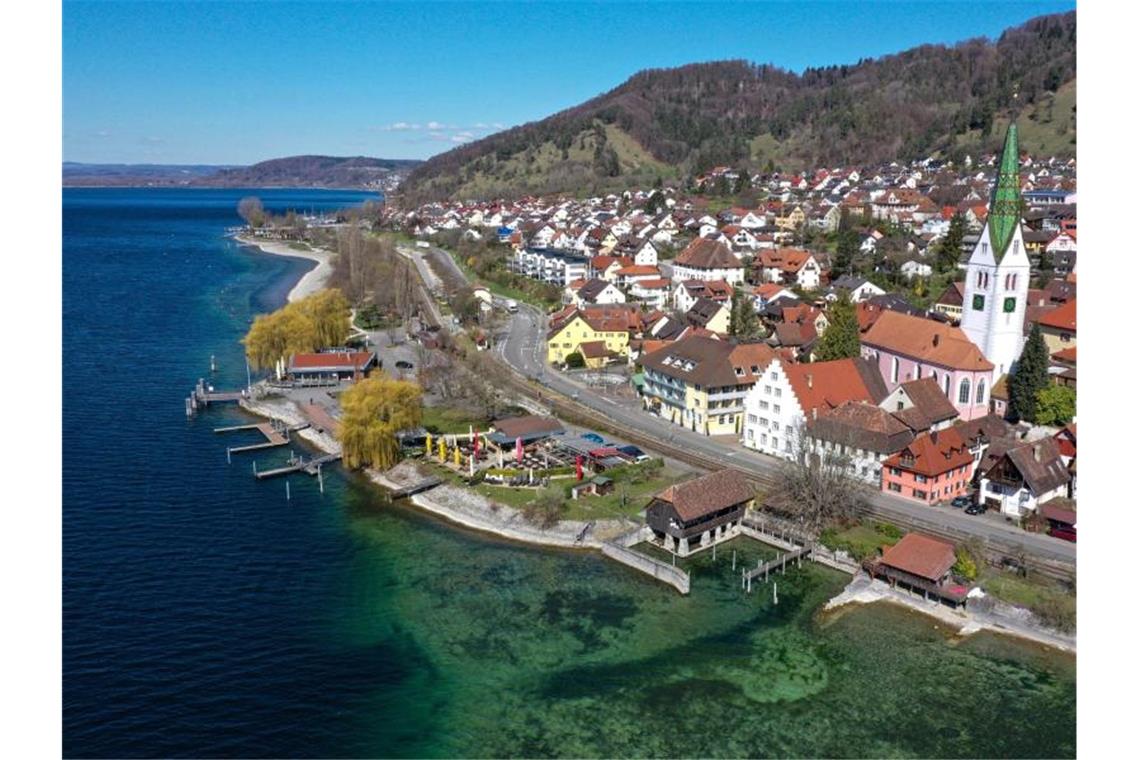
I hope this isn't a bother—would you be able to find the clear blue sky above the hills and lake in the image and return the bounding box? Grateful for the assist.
[63,0,1074,164]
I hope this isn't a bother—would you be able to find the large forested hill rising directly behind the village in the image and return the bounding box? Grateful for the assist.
[400,13,1076,202]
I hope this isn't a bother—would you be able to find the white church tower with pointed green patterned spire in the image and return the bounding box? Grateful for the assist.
[961,123,1029,386]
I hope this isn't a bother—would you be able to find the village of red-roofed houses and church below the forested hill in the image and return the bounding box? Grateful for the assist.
[381,125,1076,540]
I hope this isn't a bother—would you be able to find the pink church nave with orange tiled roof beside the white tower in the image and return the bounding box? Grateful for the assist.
[862,311,994,419]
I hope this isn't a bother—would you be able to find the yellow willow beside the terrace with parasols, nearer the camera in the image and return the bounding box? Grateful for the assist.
[339,375,423,469]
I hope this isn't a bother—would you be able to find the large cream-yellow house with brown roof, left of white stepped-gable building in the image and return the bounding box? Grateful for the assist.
[641,335,775,435]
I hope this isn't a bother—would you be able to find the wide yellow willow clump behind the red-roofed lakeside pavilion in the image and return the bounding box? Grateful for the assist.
[243,288,351,369]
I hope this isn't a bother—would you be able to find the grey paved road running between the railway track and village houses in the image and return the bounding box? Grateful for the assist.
[495,304,1076,563]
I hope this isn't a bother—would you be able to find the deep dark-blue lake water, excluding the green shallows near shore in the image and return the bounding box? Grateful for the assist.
[63,189,405,755]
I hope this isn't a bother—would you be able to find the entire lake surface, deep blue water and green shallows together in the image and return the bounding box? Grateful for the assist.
[64,190,1076,757]
